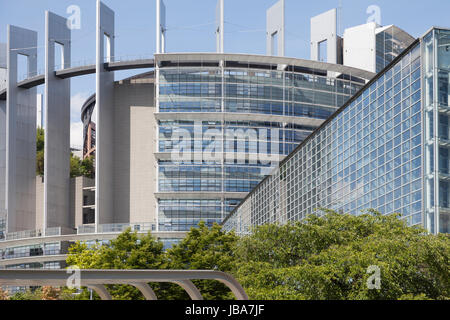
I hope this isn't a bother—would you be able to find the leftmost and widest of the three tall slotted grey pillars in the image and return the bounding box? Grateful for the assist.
[6,25,37,232]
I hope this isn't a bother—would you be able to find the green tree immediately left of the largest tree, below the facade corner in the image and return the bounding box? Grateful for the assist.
[167,222,238,300]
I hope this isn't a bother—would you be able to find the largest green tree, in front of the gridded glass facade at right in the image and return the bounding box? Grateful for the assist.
[236,210,450,299]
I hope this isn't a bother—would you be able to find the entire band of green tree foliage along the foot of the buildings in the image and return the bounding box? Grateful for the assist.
[40,210,450,300]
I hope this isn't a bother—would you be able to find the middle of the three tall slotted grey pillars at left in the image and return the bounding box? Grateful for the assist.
[43,11,71,235]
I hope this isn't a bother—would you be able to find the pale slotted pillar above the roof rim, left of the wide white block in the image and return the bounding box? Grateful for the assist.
[266,0,285,57]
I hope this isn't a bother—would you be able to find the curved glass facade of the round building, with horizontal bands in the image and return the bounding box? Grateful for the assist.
[156,61,368,231]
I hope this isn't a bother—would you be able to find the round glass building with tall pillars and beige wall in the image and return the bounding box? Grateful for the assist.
[0,0,414,268]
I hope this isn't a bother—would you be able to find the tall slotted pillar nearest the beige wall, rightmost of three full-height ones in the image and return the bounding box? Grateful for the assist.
[95,0,114,232]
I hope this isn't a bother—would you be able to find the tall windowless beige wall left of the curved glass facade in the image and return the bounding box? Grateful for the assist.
[114,81,157,223]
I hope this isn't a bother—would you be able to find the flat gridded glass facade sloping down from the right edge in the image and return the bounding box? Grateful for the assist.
[223,29,450,233]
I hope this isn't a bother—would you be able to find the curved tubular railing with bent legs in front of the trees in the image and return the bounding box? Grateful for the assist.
[0,269,248,300]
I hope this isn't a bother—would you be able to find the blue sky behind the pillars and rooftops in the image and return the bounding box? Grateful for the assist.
[0,0,450,144]
